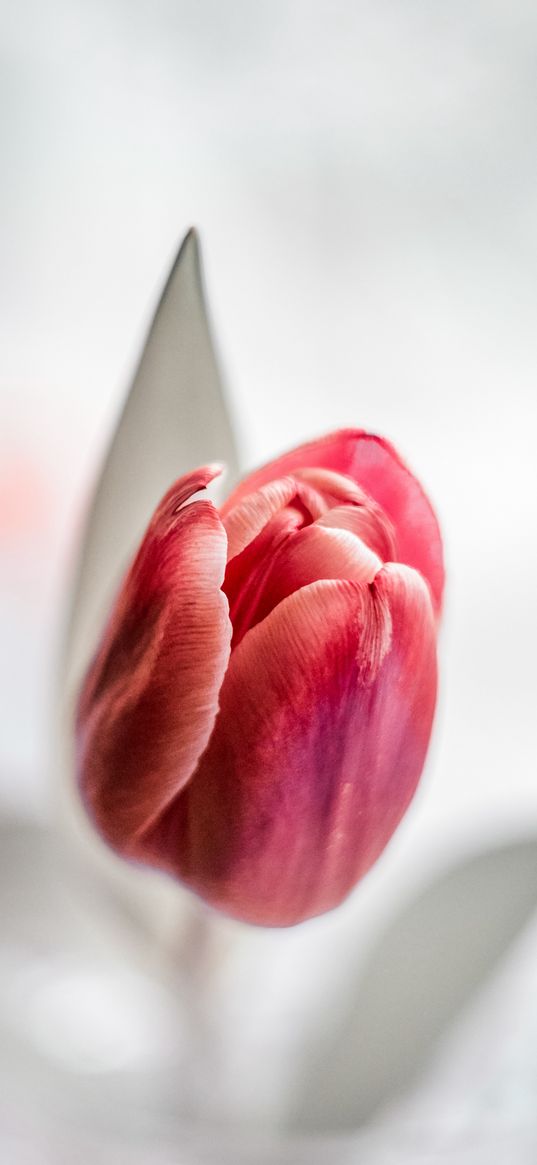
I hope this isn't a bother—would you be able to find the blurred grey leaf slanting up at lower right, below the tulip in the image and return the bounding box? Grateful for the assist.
[289,838,537,1130]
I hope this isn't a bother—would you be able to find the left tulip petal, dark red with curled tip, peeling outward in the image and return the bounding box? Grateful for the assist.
[77,466,232,856]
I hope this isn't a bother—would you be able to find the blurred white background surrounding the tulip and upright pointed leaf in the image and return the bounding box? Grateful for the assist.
[0,0,537,1159]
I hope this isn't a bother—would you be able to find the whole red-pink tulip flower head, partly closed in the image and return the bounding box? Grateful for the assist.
[77,430,444,926]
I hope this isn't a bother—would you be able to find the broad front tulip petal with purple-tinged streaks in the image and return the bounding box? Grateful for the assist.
[146,566,436,925]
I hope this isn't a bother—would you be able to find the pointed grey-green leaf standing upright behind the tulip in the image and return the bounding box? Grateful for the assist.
[61,231,236,691]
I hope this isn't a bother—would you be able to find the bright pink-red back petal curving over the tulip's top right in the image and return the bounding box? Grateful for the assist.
[220,429,444,613]
